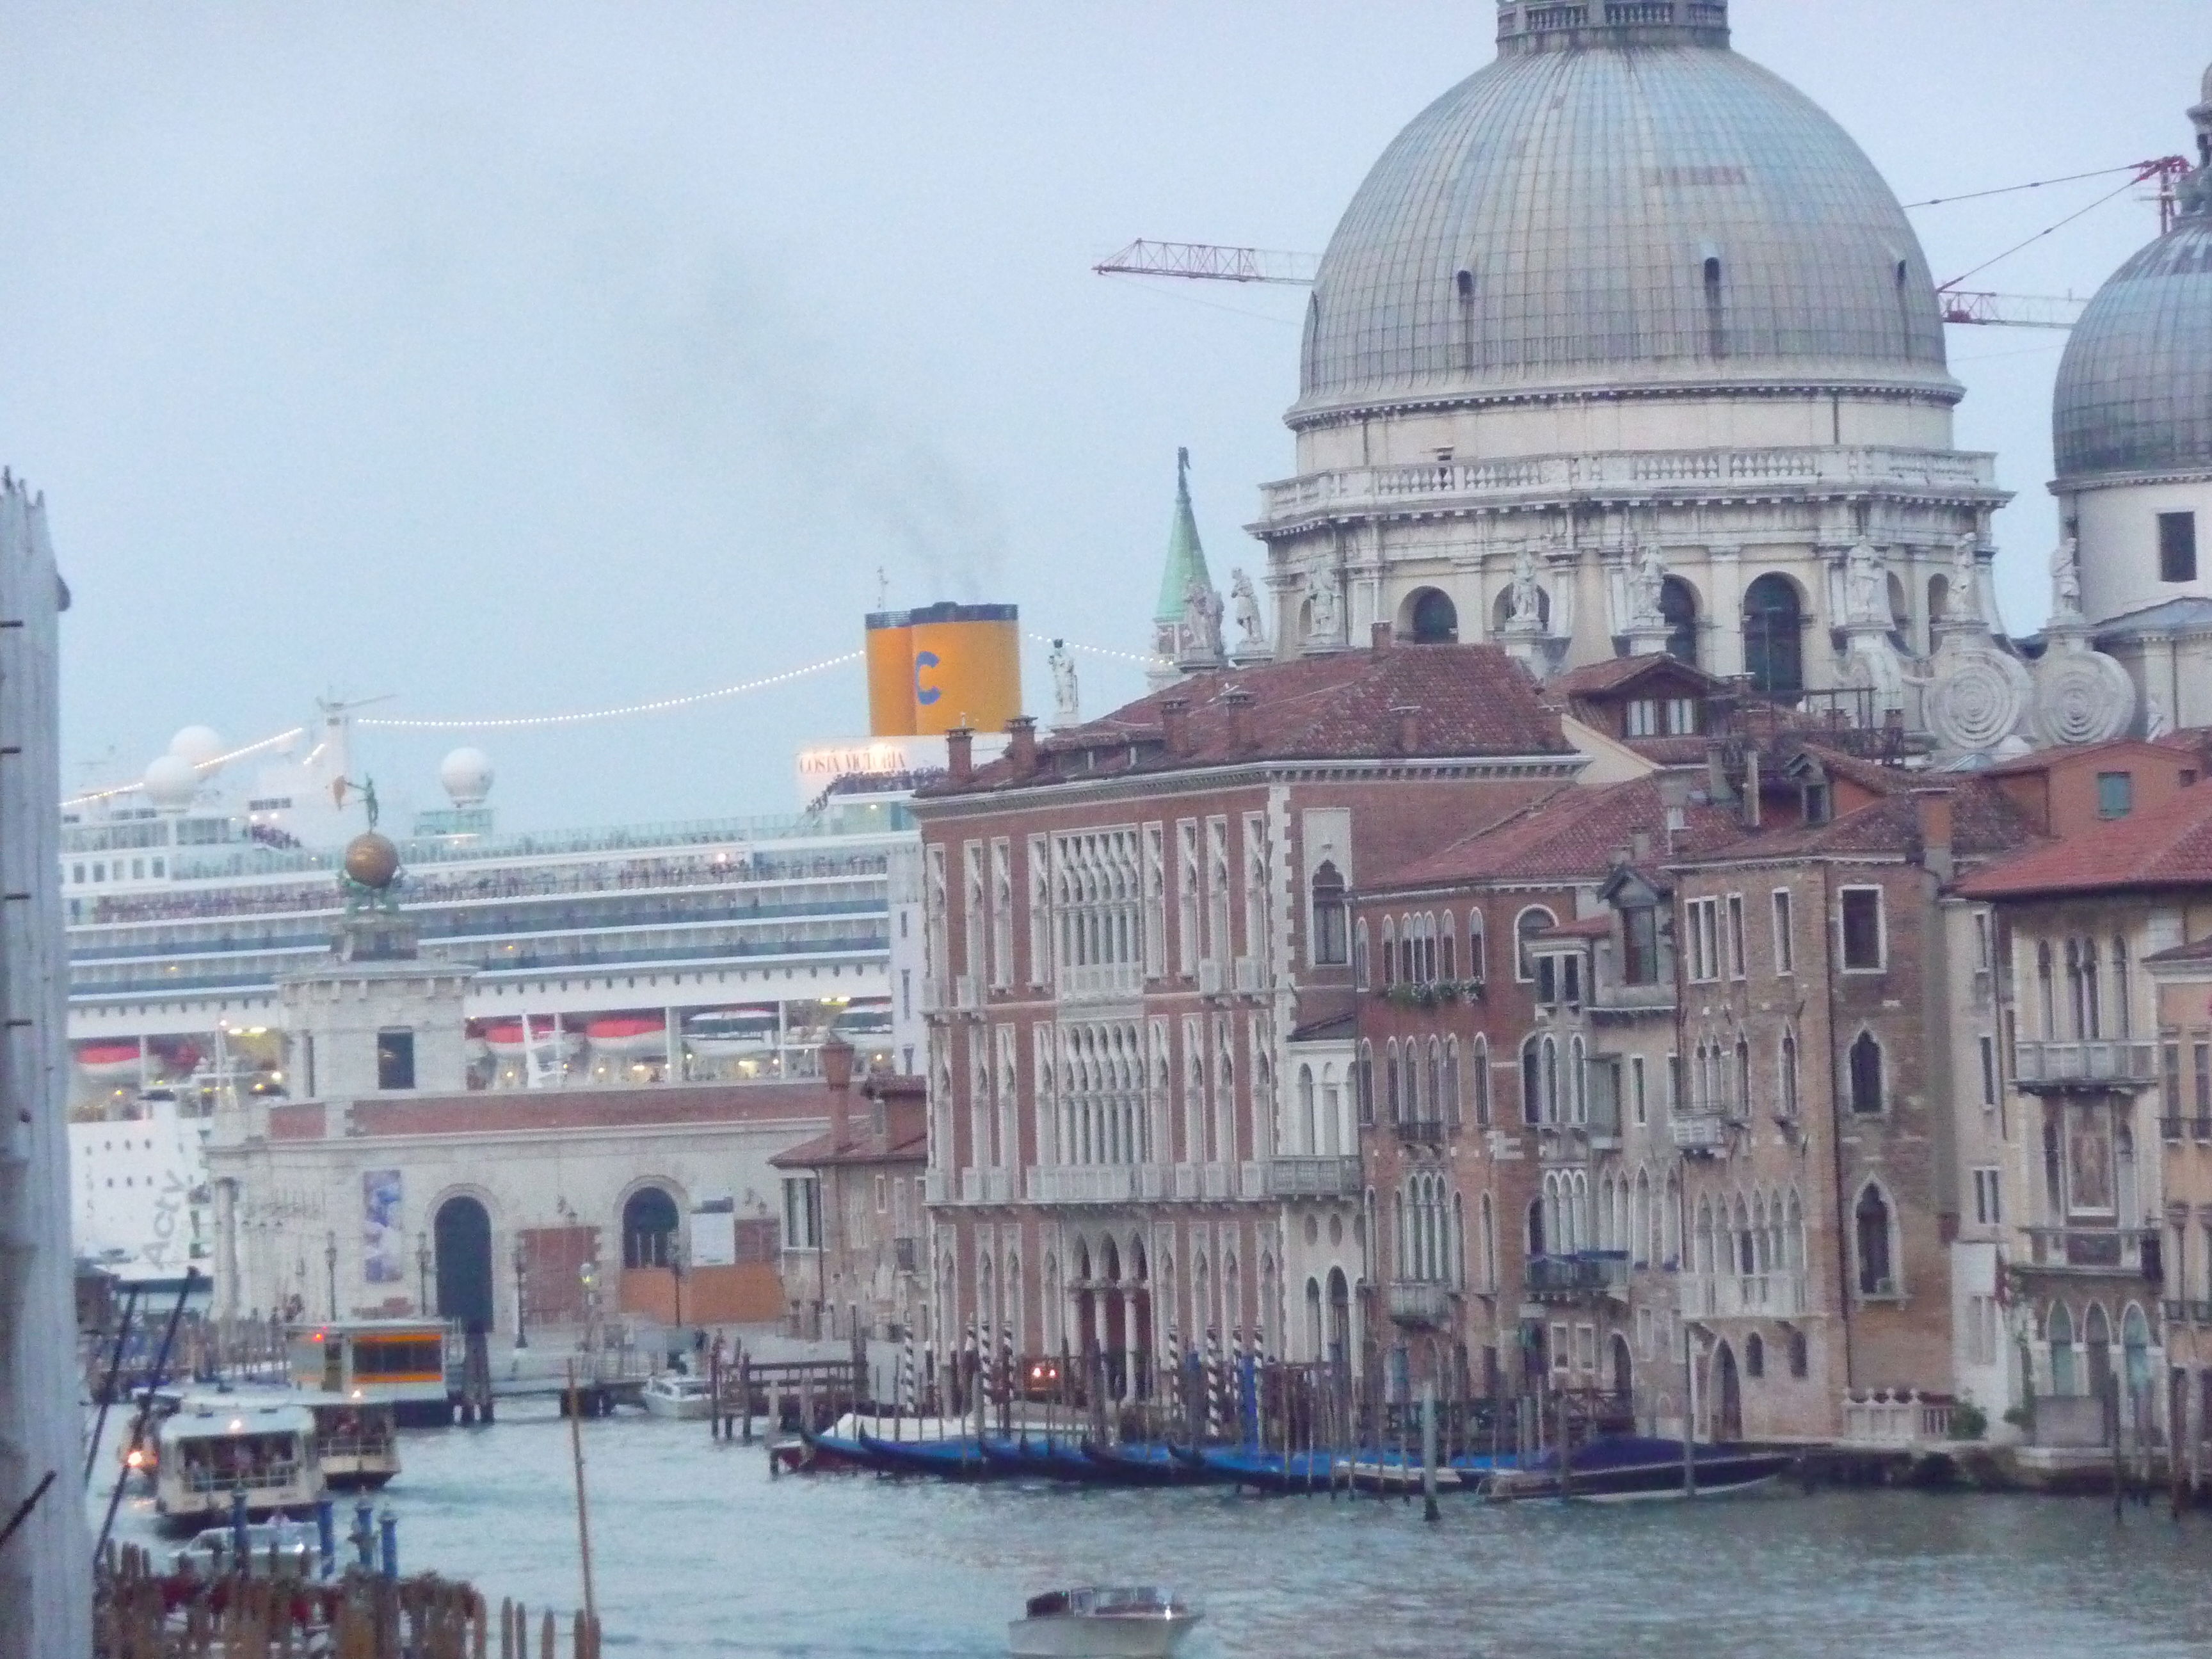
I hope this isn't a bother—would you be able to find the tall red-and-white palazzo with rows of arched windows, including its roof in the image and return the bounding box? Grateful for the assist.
[916,629,1583,1393]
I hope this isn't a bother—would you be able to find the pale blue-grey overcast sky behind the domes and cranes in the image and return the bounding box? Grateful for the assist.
[0,0,2212,828]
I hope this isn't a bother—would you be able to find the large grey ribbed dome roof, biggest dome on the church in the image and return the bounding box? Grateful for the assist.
[1292,26,1958,421]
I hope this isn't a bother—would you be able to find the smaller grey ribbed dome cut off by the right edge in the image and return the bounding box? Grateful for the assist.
[2051,207,2212,480]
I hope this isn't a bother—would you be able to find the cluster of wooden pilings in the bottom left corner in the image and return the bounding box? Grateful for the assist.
[93,1544,600,1659]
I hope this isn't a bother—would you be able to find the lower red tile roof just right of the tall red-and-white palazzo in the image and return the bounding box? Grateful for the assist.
[1367,774,1741,892]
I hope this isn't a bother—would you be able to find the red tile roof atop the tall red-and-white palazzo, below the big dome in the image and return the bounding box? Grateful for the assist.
[920,644,1573,799]
